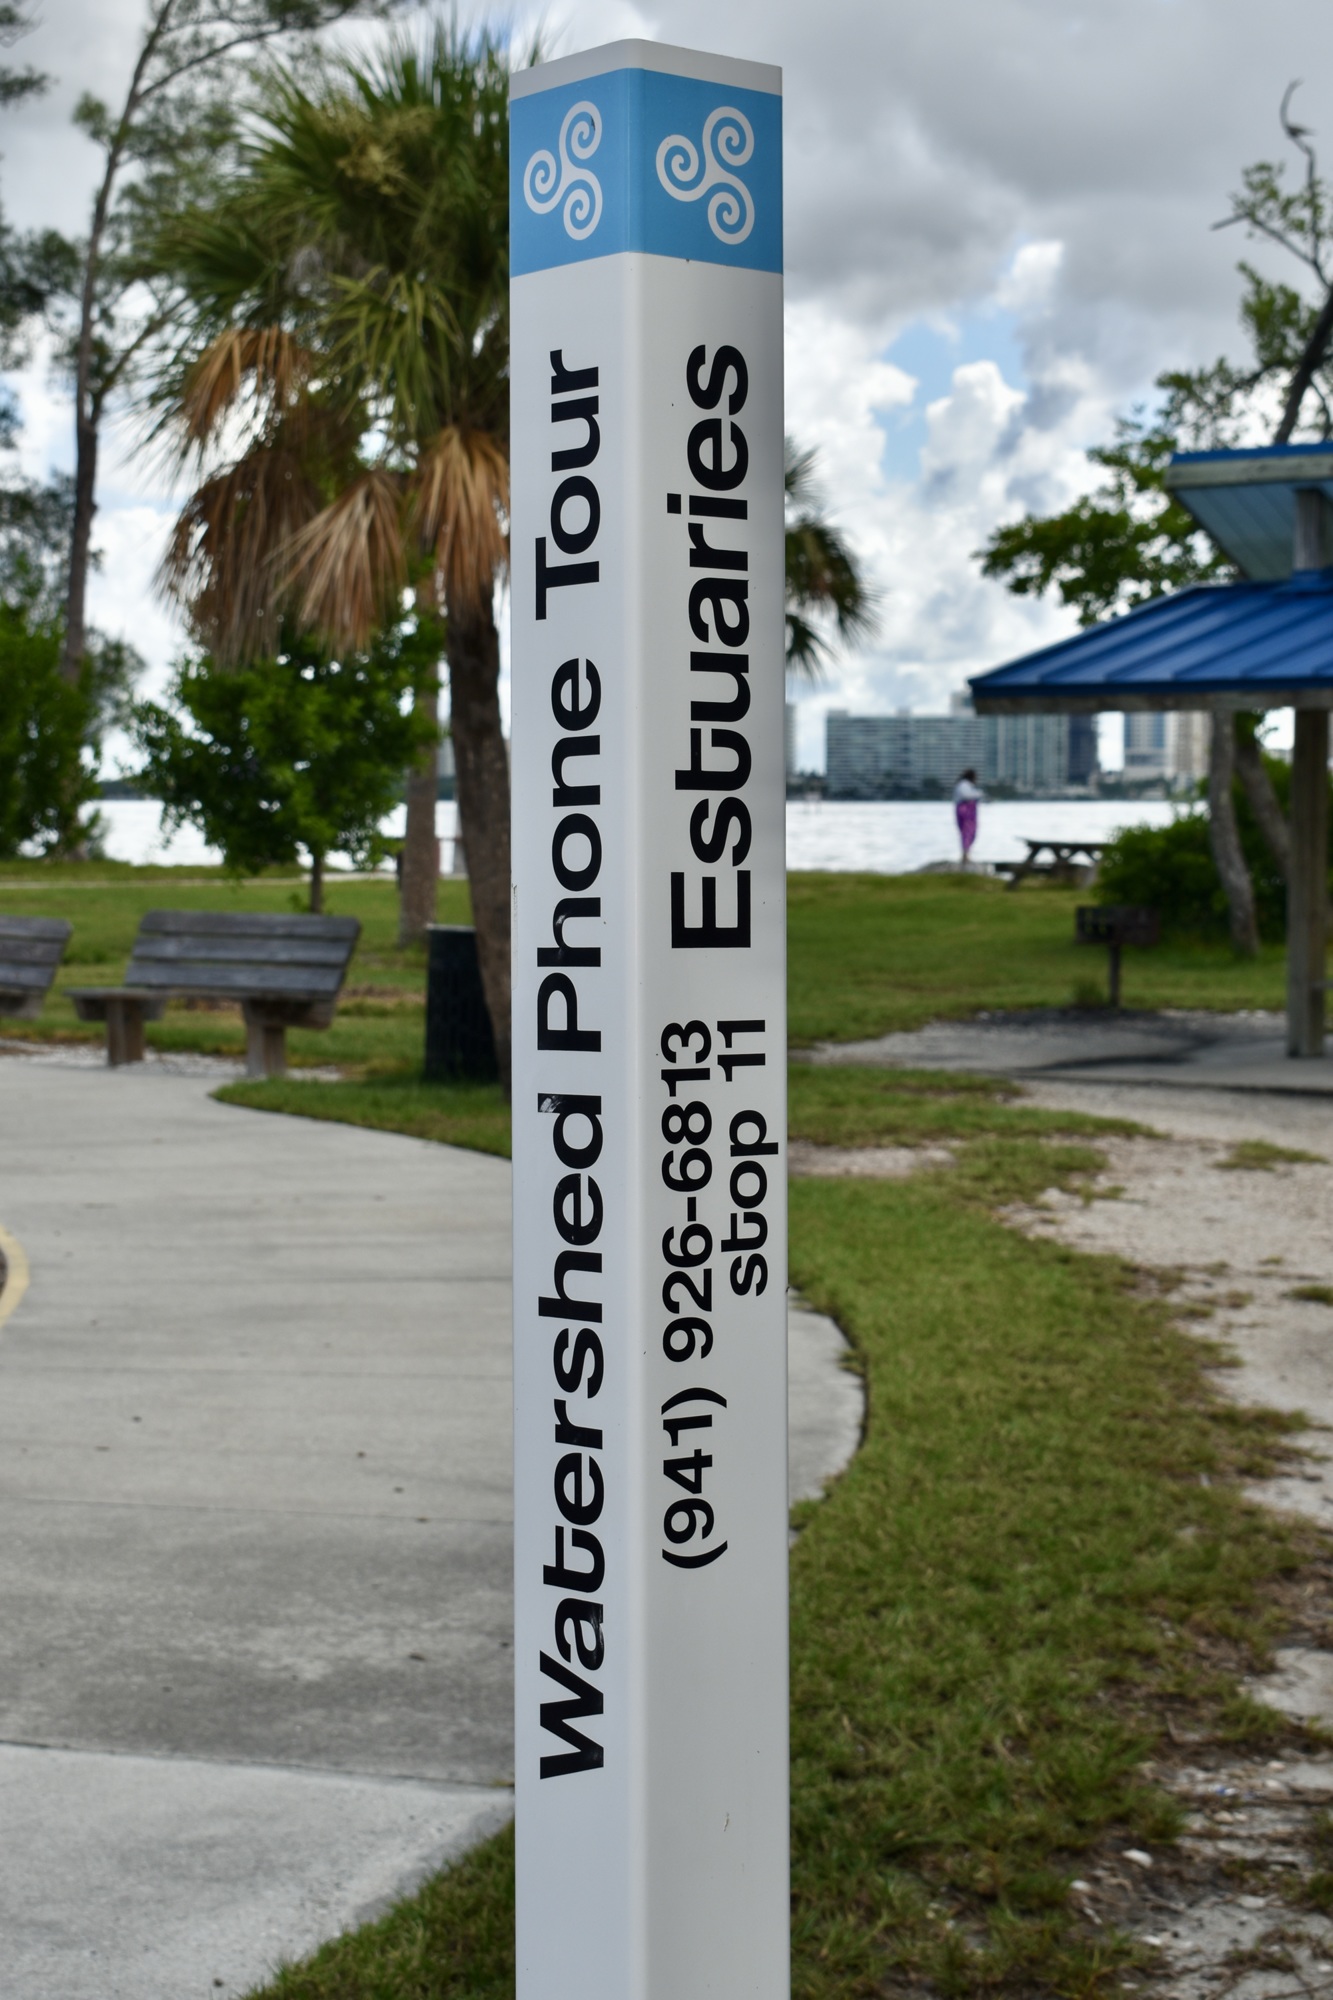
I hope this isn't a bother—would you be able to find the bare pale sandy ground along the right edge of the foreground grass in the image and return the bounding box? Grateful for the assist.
[1011,1082,1333,2000]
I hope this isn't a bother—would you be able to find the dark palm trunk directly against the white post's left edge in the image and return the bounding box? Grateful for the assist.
[448,602,510,1096]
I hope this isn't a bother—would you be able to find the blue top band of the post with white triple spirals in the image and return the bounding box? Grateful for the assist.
[508,44,783,278]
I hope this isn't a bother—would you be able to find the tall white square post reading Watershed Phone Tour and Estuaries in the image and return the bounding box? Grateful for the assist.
[510,42,789,2000]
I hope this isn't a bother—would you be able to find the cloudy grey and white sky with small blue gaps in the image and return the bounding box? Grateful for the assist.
[0,0,1333,766]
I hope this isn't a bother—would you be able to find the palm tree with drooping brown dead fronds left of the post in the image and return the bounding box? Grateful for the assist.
[156,26,510,1078]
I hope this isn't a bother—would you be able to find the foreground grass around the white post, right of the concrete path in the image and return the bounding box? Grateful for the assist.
[242,1066,1313,2000]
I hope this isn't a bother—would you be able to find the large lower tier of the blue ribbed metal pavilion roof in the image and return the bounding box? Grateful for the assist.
[971,570,1333,714]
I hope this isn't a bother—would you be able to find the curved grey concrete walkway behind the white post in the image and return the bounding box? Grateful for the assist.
[0,1060,861,2000]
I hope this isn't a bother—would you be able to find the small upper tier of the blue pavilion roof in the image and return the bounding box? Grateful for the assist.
[1165,444,1333,582]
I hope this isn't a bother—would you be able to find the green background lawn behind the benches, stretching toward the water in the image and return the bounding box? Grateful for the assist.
[0,862,1285,1074]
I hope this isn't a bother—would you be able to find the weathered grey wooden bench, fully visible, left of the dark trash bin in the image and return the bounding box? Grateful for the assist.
[70,910,360,1076]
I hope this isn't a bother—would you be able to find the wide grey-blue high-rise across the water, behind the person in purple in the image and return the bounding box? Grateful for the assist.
[825,698,1071,798]
